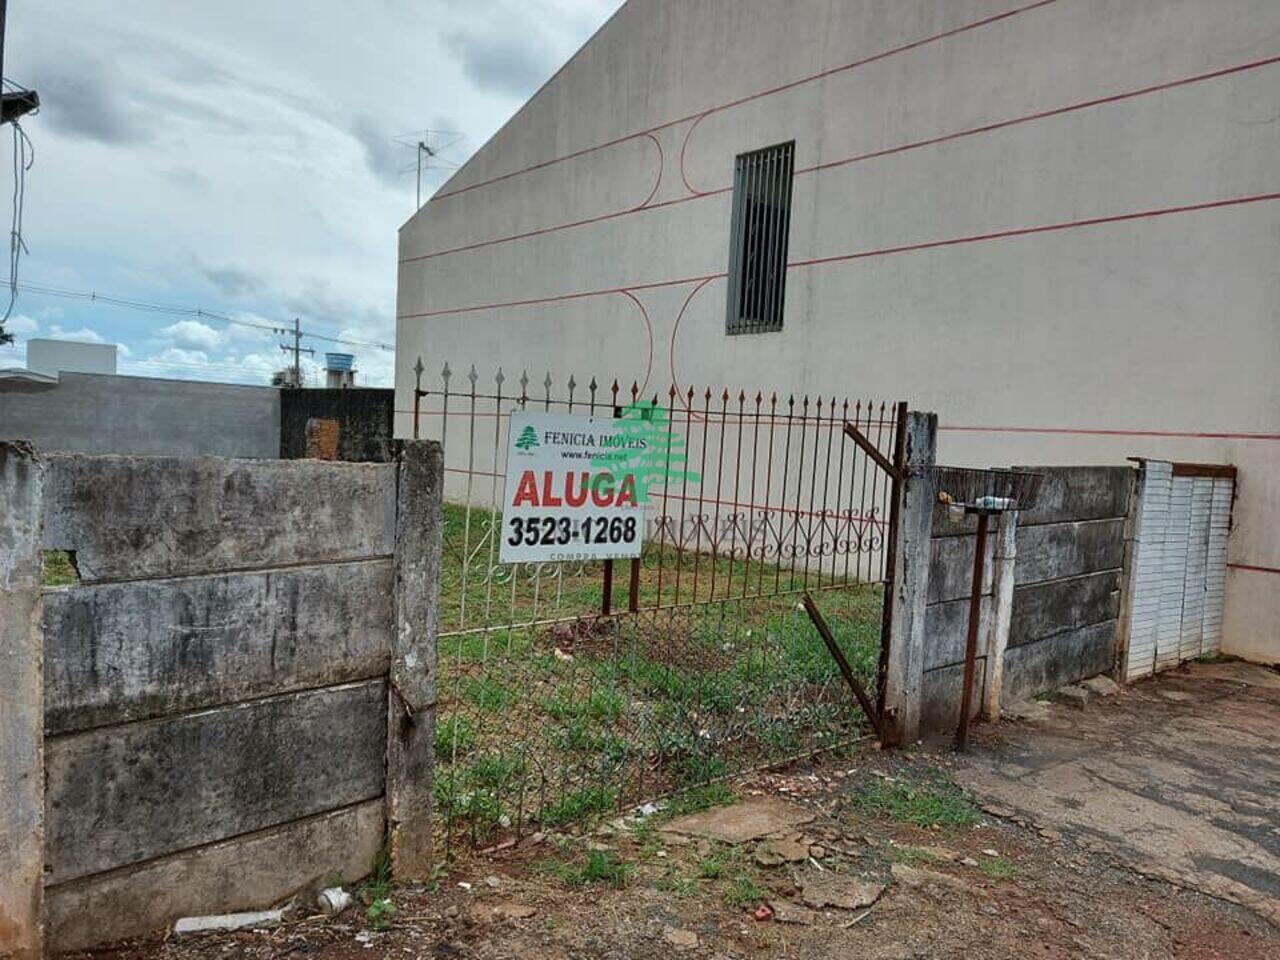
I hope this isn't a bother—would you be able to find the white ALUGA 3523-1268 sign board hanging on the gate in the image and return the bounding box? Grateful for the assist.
[499,411,644,563]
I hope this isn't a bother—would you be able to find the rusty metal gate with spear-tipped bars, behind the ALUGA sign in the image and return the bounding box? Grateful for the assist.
[413,361,906,847]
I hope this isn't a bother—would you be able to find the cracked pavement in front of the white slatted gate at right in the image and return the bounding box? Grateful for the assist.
[957,663,1280,927]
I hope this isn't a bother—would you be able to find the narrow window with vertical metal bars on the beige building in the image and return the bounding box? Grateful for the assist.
[724,141,796,334]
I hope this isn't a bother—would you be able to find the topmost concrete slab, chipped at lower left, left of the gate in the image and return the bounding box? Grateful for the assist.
[44,456,396,581]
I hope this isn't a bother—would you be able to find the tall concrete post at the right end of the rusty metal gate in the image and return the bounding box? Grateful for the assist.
[884,411,938,744]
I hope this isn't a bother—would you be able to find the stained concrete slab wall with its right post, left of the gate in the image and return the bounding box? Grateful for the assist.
[0,443,442,955]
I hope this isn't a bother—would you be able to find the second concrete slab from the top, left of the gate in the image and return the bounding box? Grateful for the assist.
[45,559,392,733]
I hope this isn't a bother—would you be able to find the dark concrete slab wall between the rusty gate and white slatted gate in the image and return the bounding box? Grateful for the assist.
[923,467,1134,730]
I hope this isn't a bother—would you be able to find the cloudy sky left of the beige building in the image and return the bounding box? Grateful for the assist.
[0,0,621,385]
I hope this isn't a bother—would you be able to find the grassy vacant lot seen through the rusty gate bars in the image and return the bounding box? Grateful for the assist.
[435,506,882,849]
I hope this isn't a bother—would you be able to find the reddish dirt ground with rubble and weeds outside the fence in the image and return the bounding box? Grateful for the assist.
[72,668,1280,960]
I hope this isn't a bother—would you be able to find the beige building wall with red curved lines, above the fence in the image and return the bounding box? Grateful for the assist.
[397,0,1280,660]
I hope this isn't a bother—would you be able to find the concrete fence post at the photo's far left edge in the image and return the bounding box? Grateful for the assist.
[0,440,45,960]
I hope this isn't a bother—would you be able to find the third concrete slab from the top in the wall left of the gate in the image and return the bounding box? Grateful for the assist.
[45,680,387,885]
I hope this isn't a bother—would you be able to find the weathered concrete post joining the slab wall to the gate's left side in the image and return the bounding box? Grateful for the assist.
[387,440,444,879]
